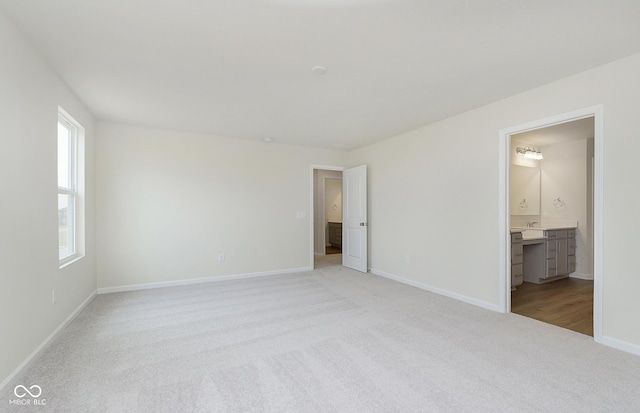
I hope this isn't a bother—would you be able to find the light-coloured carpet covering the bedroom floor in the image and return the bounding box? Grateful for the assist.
[0,256,640,413]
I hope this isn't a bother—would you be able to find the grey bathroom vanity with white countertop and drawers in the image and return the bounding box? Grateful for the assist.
[511,227,576,287]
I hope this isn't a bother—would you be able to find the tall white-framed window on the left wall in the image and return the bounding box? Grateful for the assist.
[58,108,84,264]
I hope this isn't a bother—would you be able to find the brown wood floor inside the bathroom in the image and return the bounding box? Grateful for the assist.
[511,278,593,336]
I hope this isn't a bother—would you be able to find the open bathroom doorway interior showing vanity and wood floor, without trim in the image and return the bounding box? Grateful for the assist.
[509,116,595,336]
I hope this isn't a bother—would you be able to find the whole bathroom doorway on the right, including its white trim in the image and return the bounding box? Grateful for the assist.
[499,106,603,342]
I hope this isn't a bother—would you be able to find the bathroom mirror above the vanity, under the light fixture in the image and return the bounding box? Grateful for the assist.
[509,164,540,215]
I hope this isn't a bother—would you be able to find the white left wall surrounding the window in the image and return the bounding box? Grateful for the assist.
[0,13,96,392]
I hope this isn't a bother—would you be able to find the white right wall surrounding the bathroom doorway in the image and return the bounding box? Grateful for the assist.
[349,50,640,352]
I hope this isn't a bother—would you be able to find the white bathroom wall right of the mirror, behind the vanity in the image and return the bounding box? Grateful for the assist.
[540,139,593,279]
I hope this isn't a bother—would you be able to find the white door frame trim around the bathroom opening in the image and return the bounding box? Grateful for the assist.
[498,105,604,343]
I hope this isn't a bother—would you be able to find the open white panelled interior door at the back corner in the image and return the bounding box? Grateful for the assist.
[342,165,367,272]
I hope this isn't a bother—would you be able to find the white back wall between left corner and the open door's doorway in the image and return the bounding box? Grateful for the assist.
[96,123,346,288]
